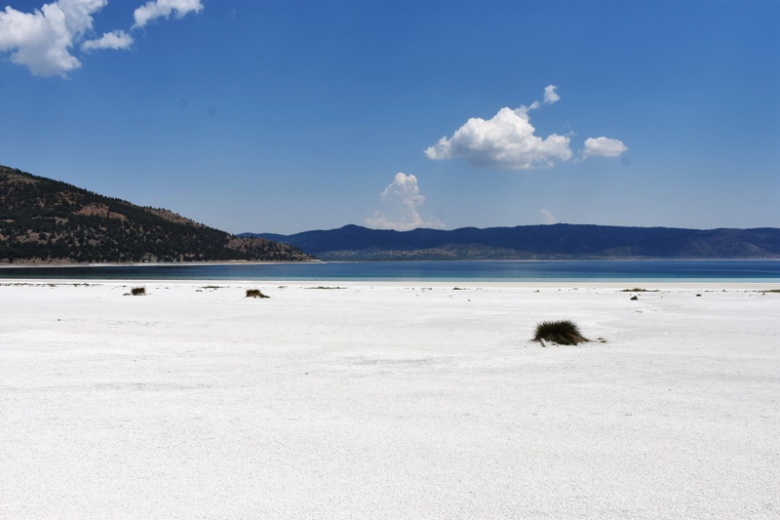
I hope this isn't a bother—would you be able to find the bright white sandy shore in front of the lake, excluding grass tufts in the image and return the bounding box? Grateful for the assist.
[0,281,780,520]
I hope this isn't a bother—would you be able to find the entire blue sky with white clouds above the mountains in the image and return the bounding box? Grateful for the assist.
[0,0,780,233]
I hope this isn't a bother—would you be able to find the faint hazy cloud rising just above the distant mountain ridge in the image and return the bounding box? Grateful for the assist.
[365,172,444,231]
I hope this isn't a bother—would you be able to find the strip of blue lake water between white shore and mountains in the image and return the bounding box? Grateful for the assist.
[0,260,780,283]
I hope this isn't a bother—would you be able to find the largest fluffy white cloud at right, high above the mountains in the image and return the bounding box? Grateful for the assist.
[425,103,572,170]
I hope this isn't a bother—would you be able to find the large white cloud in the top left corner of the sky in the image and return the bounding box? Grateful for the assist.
[0,0,108,76]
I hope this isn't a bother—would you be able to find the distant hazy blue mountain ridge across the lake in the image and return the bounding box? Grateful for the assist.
[238,224,780,260]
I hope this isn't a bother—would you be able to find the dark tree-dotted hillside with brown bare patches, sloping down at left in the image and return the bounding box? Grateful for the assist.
[0,166,313,264]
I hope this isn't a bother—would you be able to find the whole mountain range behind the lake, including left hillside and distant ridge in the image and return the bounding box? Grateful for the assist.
[0,166,780,264]
